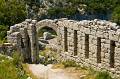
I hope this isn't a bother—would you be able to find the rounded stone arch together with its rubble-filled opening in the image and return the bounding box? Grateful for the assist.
[36,19,59,49]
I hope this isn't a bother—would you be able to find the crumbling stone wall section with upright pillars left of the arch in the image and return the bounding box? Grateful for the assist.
[7,19,38,63]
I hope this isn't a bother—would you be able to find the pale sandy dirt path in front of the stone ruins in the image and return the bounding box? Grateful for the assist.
[28,64,84,79]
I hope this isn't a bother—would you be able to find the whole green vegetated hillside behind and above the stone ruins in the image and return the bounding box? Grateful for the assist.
[0,0,120,40]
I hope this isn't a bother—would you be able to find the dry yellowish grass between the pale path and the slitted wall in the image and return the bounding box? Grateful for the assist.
[52,64,111,79]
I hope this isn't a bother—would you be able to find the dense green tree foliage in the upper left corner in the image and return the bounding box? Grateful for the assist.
[0,0,26,26]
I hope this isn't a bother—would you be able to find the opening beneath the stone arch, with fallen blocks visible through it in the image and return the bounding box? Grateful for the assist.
[37,26,57,50]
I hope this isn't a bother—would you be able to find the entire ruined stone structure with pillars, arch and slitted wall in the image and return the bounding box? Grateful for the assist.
[8,19,120,76]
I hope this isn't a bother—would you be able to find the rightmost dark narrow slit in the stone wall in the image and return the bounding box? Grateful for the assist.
[110,40,115,68]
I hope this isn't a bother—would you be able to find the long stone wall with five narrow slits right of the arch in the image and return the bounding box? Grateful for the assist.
[57,19,120,76]
